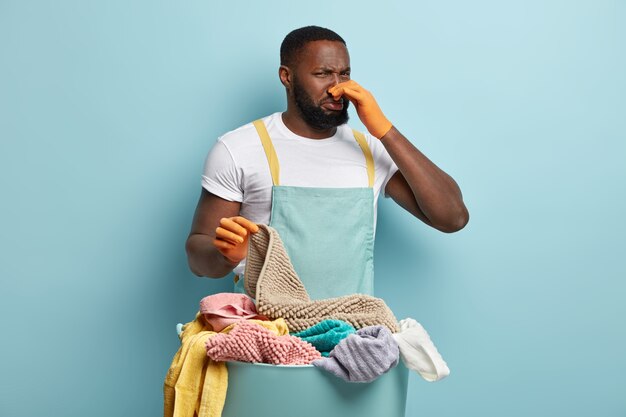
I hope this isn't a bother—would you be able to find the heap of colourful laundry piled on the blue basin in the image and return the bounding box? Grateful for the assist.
[164,225,450,416]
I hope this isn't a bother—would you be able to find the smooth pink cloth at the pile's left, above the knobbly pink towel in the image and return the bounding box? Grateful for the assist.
[200,292,268,332]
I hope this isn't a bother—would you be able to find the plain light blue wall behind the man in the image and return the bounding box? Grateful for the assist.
[0,0,626,417]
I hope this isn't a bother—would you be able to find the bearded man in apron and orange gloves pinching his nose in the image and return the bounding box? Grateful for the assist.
[186,26,469,299]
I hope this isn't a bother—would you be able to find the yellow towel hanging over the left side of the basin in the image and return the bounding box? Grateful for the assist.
[163,313,289,417]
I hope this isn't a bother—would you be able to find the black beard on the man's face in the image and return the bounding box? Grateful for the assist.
[293,79,350,130]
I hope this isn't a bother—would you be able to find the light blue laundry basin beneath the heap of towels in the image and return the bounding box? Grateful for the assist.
[222,362,408,417]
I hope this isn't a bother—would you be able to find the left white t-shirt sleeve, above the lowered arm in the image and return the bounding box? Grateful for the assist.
[202,140,243,202]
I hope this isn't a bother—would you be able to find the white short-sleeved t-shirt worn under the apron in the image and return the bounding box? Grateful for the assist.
[202,112,398,273]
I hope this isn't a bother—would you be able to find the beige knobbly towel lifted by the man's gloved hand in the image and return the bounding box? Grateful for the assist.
[244,224,399,333]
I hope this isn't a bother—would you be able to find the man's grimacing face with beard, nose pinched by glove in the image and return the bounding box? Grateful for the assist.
[291,41,350,130]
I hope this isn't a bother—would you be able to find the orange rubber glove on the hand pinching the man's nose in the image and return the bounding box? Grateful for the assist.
[328,80,393,139]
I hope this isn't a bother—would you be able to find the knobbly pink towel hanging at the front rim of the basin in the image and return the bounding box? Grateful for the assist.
[206,321,322,365]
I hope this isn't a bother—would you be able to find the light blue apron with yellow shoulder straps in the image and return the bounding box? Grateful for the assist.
[238,120,374,300]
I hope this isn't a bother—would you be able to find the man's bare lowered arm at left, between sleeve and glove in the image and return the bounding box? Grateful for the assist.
[185,188,241,278]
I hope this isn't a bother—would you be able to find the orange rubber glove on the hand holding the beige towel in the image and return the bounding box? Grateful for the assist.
[213,216,259,265]
